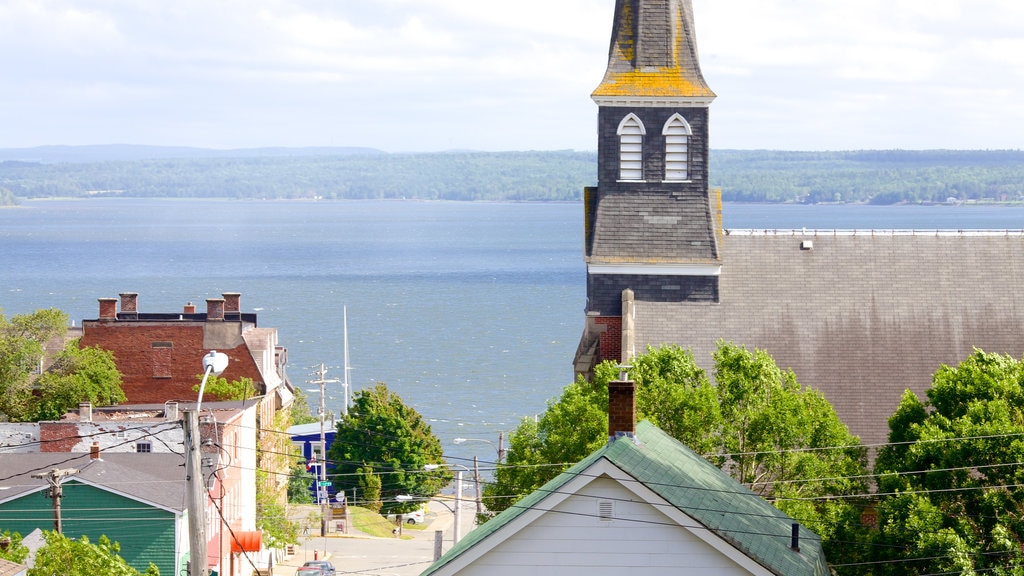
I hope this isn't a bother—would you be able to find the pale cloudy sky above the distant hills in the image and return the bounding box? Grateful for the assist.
[0,0,1024,153]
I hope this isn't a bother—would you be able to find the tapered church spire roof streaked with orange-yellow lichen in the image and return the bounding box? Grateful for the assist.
[592,0,715,105]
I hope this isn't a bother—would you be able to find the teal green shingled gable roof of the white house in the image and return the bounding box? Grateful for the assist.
[421,421,828,576]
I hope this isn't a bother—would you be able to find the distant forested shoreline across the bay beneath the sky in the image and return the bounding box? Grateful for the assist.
[0,146,1024,205]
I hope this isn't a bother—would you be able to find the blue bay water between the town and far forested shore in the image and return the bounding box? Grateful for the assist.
[0,199,1024,465]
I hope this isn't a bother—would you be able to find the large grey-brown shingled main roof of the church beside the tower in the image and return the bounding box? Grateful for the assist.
[635,231,1024,444]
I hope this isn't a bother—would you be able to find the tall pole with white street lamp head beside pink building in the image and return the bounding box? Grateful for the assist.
[188,351,227,576]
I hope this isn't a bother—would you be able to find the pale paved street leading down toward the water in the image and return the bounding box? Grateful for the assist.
[273,500,474,576]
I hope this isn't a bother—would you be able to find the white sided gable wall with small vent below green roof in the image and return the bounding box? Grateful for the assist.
[458,476,761,576]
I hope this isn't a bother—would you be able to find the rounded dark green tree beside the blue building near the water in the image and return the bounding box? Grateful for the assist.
[328,382,452,513]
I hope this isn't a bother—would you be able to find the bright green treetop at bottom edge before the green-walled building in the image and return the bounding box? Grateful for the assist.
[29,531,160,576]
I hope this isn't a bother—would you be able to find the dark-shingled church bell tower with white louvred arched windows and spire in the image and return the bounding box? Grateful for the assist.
[575,0,722,374]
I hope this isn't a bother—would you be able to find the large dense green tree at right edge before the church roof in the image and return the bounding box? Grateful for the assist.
[871,349,1024,575]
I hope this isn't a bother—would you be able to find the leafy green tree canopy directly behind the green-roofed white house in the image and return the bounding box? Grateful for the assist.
[484,342,866,558]
